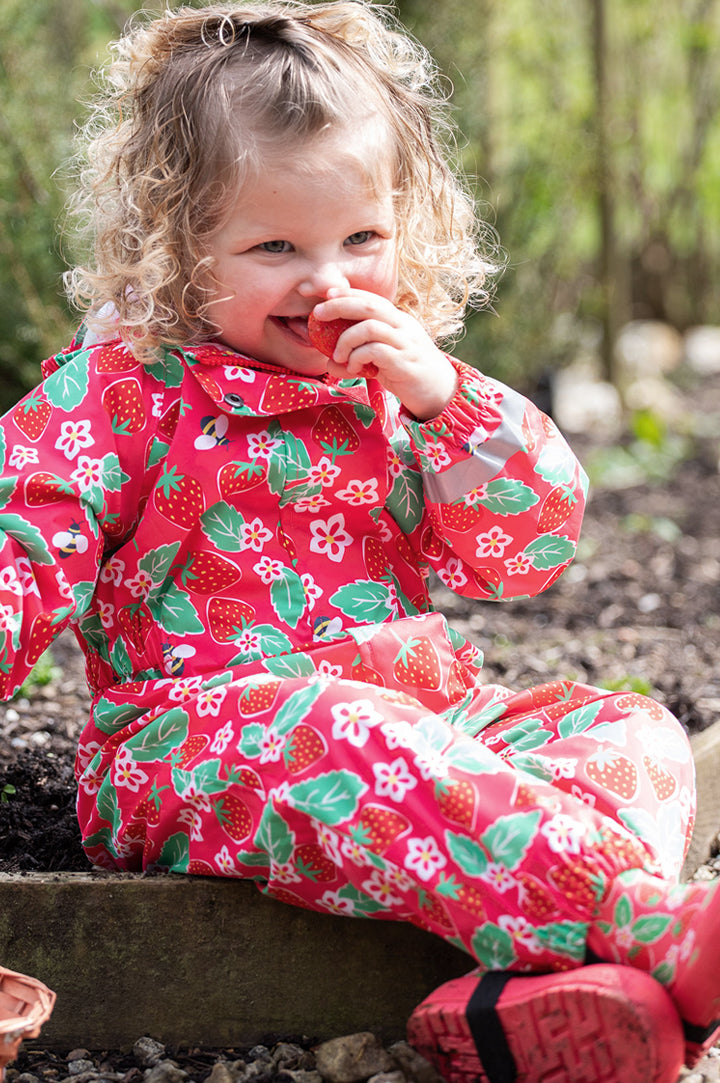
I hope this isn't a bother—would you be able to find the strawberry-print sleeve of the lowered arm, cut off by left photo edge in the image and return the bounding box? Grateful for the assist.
[0,343,166,699]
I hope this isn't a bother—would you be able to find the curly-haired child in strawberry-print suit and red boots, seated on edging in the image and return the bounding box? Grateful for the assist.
[0,0,720,1083]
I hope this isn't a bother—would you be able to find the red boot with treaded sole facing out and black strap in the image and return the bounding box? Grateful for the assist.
[408,964,684,1083]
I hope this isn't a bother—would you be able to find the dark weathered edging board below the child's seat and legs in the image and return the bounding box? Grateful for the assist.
[0,873,465,1049]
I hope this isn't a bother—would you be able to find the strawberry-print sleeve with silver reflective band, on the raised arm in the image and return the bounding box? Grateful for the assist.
[390,360,587,600]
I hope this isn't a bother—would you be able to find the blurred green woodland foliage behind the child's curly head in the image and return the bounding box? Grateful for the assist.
[0,0,720,406]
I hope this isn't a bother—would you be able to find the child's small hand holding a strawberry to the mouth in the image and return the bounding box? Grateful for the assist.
[313,288,457,420]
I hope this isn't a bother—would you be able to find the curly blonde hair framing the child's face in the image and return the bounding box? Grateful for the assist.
[66,0,494,360]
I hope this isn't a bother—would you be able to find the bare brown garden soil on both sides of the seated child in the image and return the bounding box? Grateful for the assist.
[0,363,720,872]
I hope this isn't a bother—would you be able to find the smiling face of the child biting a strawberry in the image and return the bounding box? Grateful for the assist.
[208,129,397,376]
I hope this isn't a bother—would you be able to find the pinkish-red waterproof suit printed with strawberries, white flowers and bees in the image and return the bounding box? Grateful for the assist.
[0,341,693,969]
